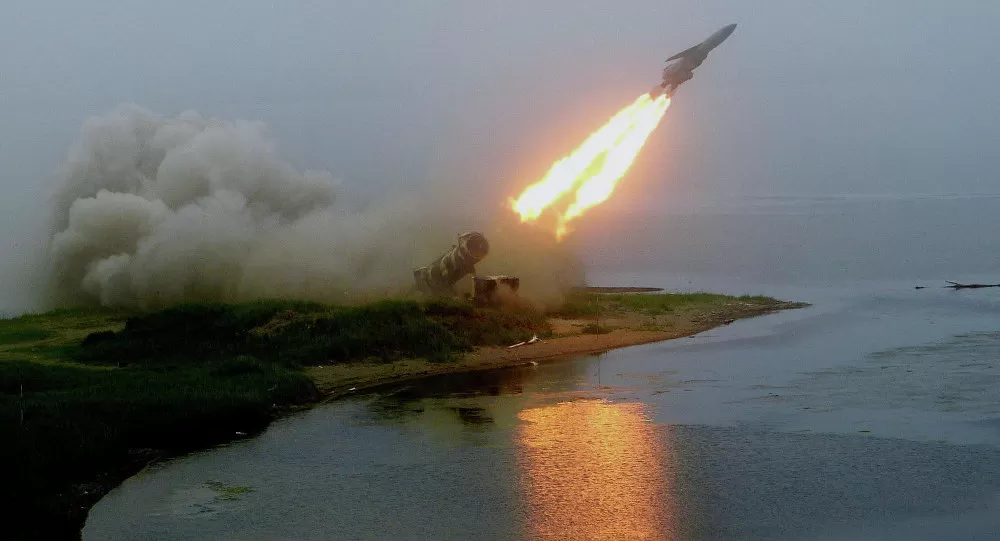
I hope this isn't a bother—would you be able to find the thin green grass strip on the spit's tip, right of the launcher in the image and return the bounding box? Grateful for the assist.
[552,292,778,318]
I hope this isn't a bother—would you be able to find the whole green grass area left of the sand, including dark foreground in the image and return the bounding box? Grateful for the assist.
[0,300,548,539]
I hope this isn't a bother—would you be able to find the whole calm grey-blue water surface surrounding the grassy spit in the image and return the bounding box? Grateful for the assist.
[84,198,1000,540]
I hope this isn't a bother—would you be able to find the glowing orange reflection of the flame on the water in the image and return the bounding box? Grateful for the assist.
[517,400,675,539]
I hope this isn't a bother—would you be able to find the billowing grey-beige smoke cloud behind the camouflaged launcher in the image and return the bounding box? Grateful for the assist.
[49,105,577,308]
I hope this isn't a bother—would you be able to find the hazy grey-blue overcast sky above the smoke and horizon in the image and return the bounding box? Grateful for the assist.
[0,0,1000,237]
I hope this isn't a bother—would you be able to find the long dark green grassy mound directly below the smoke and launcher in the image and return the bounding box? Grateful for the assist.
[68,300,547,369]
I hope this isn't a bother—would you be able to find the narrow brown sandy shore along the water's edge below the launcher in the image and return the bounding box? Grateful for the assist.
[306,301,807,400]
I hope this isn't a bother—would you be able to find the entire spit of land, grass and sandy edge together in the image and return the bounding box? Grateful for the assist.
[0,294,800,539]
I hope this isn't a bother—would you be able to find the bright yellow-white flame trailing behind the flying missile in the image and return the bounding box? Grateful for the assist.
[511,94,670,239]
